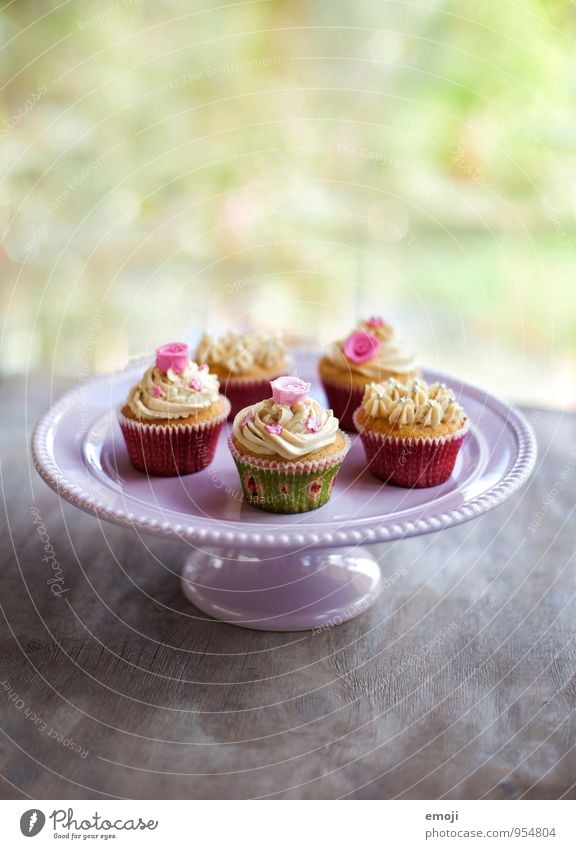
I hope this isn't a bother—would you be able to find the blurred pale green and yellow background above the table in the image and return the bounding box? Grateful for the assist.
[0,0,576,407]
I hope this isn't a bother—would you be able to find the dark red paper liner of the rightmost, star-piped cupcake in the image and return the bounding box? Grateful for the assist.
[357,408,469,489]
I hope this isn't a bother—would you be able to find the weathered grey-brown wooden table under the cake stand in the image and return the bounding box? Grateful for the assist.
[0,379,576,799]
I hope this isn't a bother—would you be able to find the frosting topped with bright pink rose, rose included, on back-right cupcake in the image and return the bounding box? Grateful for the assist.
[326,318,418,381]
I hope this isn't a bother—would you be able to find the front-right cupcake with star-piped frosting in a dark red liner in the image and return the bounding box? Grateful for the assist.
[354,378,469,487]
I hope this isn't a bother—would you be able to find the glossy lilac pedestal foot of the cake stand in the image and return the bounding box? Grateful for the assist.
[182,547,382,631]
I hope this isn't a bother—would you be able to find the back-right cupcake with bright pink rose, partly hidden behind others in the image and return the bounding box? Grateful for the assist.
[318,316,418,431]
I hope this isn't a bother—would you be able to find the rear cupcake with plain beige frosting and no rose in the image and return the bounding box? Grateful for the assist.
[195,332,290,419]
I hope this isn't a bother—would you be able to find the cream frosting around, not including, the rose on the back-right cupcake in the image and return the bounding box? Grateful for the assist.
[326,321,418,381]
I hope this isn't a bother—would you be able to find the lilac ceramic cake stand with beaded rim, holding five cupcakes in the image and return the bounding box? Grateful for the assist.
[32,353,536,631]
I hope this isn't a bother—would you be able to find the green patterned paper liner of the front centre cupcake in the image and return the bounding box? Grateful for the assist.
[228,437,351,513]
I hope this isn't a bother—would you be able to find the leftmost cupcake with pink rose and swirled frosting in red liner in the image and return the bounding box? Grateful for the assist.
[118,342,230,475]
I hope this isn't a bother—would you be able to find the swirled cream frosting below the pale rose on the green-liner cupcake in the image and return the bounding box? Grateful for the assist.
[233,398,338,460]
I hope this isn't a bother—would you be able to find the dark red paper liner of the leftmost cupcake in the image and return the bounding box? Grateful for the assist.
[118,404,228,477]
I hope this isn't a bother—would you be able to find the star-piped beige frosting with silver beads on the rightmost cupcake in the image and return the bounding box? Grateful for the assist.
[362,378,466,427]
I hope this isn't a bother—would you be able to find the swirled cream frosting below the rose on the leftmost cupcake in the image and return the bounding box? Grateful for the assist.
[127,360,220,419]
